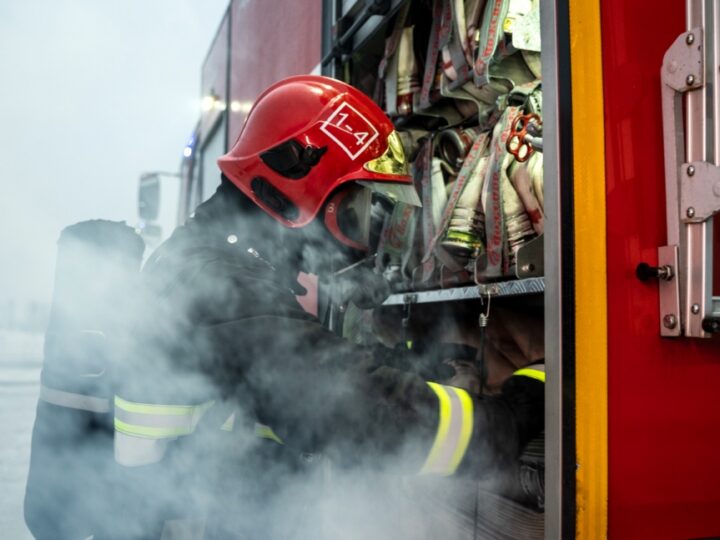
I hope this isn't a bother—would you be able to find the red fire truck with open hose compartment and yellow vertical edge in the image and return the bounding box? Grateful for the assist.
[139,0,720,540]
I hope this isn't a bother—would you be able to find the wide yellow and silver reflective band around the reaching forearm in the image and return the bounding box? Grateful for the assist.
[420,382,473,476]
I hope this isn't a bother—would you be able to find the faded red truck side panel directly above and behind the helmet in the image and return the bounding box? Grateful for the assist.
[228,0,322,146]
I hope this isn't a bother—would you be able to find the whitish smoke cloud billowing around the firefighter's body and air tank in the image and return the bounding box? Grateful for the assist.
[21,182,541,540]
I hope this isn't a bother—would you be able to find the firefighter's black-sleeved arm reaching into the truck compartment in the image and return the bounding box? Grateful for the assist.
[200,317,544,474]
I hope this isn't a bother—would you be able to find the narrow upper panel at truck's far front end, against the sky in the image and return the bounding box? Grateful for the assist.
[200,14,230,144]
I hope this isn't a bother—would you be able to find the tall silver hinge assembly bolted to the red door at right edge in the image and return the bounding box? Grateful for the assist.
[658,9,720,337]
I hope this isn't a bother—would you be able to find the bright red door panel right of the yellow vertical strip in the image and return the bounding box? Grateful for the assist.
[600,0,720,540]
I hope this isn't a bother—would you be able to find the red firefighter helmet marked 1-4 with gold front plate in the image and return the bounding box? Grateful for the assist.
[218,75,420,249]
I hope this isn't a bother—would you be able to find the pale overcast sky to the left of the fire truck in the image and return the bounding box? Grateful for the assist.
[0,0,228,302]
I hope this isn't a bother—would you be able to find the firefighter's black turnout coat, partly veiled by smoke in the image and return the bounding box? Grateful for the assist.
[112,182,544,537]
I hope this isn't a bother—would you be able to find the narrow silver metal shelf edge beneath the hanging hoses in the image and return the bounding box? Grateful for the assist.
[382,277,545,306]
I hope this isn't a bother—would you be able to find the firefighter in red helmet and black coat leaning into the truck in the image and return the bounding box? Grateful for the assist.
[114,76,544,538]
